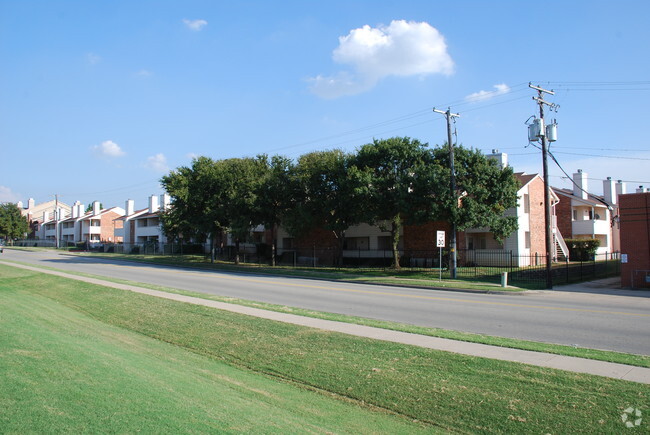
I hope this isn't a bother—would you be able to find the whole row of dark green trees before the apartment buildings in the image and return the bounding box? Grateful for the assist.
[161,137,519,267]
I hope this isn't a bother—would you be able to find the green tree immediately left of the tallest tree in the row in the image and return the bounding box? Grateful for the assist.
[293,150,370,264]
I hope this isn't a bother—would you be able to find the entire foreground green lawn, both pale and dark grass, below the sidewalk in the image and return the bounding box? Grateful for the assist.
[0,266,650,433]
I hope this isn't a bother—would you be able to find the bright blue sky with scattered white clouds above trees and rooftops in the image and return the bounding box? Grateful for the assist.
[0,0,650,208]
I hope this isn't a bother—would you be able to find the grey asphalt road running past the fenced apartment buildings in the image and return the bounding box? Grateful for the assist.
[0,249,650,355]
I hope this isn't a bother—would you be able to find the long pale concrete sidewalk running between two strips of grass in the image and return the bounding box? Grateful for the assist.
[3,262,650,384]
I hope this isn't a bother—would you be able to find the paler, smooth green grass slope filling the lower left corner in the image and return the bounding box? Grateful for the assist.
[0,267,434,433]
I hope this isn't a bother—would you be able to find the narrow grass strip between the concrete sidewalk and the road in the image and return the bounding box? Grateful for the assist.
[6,263,650,368]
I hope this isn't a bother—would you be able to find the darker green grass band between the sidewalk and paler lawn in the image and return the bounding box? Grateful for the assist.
[0,266,650,433]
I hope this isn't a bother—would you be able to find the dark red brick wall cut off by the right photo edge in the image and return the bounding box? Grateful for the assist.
[618,193,650,288]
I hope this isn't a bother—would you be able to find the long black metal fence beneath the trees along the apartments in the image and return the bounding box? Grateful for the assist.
[14,240,620,288]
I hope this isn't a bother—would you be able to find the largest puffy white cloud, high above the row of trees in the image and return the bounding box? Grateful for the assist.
[308,20,454,98]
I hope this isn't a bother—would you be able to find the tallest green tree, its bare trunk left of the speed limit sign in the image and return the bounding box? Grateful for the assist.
[355,137,437,269]
